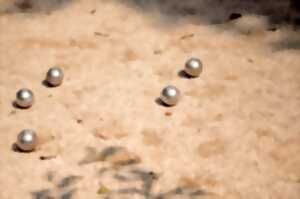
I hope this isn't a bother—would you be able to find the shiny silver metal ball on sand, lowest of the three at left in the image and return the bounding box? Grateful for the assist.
[16,129,37,151]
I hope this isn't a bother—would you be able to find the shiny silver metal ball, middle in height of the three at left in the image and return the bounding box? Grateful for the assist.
[15,88,34,108]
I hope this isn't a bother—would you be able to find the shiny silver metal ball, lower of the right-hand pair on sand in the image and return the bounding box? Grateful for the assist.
[160,86,180,106]
